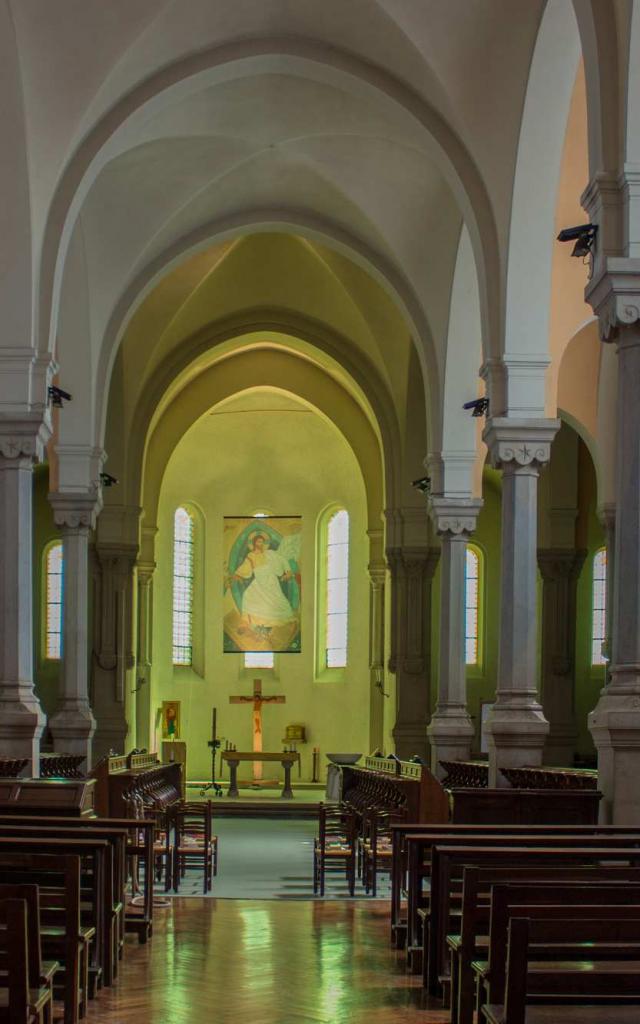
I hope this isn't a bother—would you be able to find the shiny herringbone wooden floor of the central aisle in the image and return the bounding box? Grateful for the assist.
[87,898,449,1024]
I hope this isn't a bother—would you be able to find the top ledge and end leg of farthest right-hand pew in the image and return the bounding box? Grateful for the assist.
[390,822,638,948]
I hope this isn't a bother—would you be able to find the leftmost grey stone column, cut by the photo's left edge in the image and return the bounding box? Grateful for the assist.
[0,421,49,776]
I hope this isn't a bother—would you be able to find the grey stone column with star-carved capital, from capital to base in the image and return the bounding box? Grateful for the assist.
[483,418,559,786]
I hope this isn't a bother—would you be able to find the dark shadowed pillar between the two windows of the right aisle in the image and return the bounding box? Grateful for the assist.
[538,548,587,766]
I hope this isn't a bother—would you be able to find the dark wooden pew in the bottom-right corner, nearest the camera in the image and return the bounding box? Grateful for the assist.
[482,908,640,1024]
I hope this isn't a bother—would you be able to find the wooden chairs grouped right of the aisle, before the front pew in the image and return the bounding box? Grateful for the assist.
[313,803,403,896]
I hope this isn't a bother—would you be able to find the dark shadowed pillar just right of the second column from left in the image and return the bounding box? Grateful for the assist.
[92,506,140,760]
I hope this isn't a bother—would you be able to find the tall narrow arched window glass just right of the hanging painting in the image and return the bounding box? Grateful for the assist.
[326,509,349,669]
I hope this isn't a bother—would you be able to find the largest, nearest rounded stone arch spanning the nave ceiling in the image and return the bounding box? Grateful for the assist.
[37,38,500,385]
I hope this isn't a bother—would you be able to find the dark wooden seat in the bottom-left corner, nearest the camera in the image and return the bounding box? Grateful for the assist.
[0,894,52,1024]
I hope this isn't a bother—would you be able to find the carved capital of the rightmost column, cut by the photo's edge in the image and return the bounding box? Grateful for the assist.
[585,256,640,344]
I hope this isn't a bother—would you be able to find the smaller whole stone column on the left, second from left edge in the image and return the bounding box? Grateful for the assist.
[49,493,101,770]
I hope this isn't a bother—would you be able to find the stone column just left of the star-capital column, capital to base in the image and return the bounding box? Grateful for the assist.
[427,496,482,778]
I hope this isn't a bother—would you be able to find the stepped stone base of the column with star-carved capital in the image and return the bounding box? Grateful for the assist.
[486,703,549,788]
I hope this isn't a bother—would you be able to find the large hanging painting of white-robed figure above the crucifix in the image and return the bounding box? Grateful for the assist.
[223,516,302,654]
